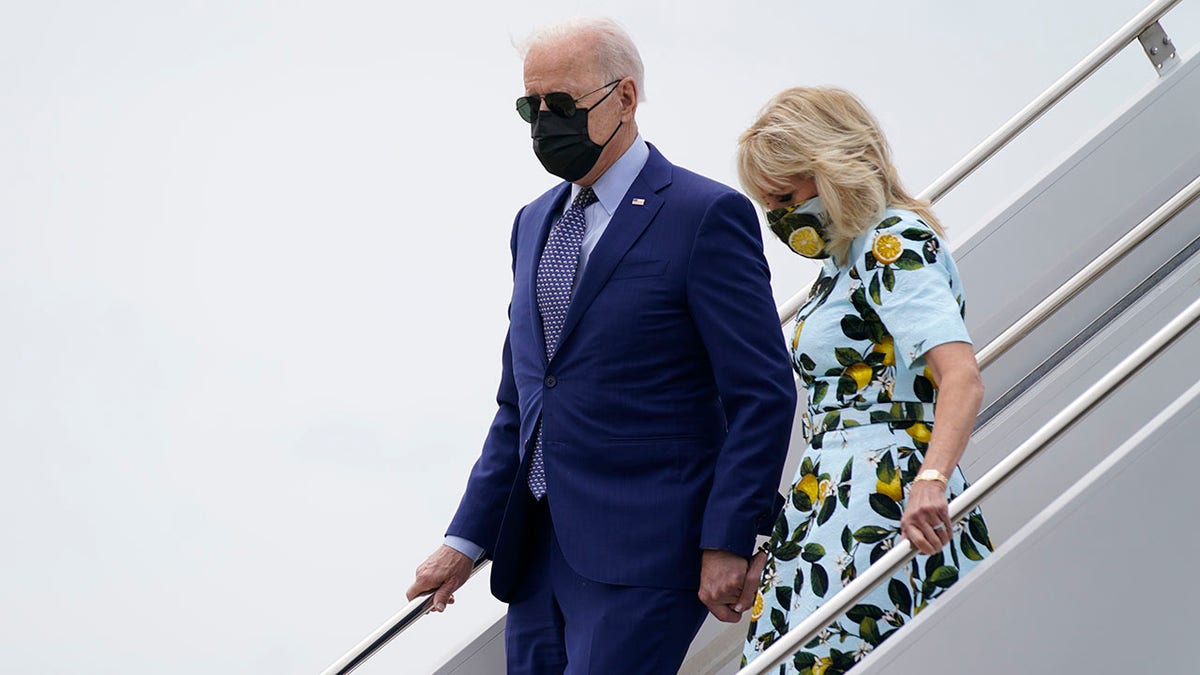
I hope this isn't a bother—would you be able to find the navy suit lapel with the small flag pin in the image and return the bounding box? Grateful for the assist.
[558,145,671,351]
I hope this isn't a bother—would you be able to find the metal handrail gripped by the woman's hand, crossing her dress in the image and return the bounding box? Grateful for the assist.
[738,290,1200,675]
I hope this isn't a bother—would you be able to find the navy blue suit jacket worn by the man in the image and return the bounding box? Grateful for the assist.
[448,145,796,599]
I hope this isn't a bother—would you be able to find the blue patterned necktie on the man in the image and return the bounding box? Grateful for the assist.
[529,187,596,500]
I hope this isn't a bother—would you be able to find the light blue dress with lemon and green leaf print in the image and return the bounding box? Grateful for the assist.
[743,209,991,675]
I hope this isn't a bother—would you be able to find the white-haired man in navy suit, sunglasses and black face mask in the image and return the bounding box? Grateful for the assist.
[408,20,796,674]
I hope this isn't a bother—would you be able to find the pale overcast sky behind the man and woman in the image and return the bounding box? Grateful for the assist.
[0,0,1200,675]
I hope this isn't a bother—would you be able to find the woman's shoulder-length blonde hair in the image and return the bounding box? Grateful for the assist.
[738,86,943,263]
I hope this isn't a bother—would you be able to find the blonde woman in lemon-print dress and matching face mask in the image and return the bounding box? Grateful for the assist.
[738,88,991,675]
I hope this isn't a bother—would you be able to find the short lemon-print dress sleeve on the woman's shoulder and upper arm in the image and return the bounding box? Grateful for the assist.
[854,215,971,369]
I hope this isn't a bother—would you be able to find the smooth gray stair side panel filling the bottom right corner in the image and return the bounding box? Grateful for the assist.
[856,353,1200,675]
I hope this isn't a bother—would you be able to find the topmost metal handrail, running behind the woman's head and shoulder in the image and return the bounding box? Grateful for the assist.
[779,0,1182,323]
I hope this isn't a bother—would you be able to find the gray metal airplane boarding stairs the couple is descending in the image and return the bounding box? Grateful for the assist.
[326,0,1200,675]
